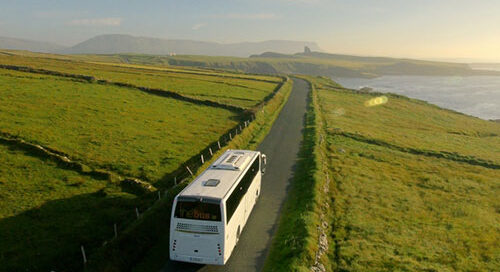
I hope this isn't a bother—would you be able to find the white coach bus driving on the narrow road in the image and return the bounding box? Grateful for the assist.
[170,150,266,265]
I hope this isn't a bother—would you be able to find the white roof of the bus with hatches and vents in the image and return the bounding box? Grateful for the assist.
[179,149,259,199]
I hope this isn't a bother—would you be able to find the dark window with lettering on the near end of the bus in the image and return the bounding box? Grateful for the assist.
[174,197,221,221]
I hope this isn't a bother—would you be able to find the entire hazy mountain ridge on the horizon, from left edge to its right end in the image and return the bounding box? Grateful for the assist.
[0,34,321,57]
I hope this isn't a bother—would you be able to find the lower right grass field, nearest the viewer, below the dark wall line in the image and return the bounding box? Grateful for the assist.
[328,134,500,271]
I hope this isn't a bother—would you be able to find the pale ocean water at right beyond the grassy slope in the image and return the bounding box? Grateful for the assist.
[333,76,500,120]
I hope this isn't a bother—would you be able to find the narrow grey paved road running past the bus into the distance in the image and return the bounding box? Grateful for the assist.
[163,79,309,272]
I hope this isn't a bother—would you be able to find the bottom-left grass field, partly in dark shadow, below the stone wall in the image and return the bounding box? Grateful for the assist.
[0,144,140,271]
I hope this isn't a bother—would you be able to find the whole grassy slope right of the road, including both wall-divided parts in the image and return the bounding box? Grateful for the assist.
[315,76,500,271]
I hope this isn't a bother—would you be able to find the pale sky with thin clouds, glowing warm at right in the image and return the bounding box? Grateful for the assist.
[0,0,500,62]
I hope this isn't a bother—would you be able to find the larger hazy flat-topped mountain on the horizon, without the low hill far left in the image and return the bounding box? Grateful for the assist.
[58,34,321,57]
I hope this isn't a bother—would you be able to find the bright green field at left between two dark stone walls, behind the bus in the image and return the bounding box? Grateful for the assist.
[0,69,239,181]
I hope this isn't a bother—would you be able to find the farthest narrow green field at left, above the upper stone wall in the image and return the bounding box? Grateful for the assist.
[0,50,281,108]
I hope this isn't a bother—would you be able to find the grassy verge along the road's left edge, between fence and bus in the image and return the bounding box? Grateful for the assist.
[87,77,292,271]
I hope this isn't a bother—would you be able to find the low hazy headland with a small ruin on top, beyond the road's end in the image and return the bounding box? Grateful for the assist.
[159,51,500,78]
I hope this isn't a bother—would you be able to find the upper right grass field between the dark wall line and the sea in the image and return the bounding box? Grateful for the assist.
[317,82,500,164]
